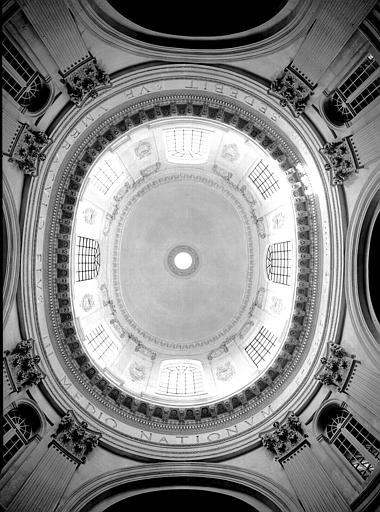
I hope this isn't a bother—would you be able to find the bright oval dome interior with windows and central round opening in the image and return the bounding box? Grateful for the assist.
[71,118,300,407]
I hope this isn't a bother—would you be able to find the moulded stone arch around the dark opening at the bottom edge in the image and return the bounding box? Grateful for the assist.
[57,462,301,512]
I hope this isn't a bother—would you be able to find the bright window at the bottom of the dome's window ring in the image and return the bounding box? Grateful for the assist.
[159,363,203,396]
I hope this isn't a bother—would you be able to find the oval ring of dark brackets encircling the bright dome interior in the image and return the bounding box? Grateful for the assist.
[49,94,317,431]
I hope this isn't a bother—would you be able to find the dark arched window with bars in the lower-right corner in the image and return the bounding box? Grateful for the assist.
[326,409,380,480]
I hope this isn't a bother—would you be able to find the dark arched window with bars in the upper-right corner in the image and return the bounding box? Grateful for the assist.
[324,53,380,126]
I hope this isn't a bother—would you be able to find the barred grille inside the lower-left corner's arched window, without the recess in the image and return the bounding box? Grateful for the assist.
[3,409,33,465]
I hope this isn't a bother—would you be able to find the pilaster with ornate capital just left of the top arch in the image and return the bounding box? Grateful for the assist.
[18,0,111,107]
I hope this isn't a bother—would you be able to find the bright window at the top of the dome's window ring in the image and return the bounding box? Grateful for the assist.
[165,128,212,162]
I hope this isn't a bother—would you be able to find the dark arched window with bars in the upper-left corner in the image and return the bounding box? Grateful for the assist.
[2,33,50,113]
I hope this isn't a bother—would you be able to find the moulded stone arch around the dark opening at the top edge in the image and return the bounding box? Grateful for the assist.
[74,0,317,62]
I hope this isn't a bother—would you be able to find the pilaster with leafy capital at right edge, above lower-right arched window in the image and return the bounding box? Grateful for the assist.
[315,343,380,416]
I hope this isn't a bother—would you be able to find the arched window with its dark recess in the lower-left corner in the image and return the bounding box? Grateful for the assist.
[3,405,41,466]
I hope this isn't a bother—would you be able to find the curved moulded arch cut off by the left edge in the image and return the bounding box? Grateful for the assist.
[2,173,21,326]
